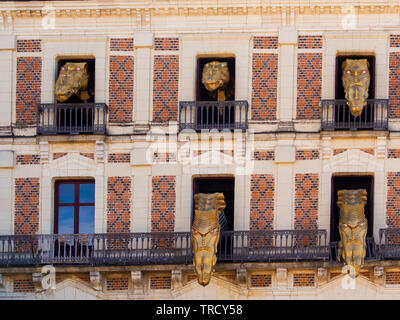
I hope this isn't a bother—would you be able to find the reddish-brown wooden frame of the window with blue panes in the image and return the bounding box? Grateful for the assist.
[53,179,96,234]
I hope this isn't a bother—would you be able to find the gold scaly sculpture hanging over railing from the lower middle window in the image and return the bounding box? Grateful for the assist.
[191,192,226,286]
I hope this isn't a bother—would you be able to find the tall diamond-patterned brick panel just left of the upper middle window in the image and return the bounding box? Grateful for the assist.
[153,55,179,122]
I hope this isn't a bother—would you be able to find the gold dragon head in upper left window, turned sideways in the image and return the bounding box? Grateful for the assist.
[55,62,93,102]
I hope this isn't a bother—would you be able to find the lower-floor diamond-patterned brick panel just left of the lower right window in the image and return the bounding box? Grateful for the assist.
[294,173,319,230]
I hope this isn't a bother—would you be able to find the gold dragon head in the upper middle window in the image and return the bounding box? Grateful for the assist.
[201,61,230,101]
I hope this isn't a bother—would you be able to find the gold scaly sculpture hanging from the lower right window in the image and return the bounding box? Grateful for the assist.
[337,189,368,276]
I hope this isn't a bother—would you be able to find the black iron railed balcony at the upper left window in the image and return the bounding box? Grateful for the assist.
[37,103,107,134]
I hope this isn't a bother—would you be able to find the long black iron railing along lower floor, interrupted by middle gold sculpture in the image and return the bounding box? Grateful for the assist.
[0,230,329,266]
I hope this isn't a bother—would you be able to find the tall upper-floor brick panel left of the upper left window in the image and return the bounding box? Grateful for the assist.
[16,57,42,127]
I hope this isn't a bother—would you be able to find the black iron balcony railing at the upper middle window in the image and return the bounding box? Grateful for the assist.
[179,101,248,131]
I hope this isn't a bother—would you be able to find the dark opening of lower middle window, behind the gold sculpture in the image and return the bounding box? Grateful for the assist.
[192,177,235,258]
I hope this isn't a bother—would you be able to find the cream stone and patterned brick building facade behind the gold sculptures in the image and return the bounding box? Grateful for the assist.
[0,0,400,299]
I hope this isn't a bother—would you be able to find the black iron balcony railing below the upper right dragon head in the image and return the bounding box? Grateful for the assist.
[321,99,389,130]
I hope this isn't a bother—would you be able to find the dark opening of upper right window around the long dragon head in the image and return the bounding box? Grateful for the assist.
[335,55,375,123]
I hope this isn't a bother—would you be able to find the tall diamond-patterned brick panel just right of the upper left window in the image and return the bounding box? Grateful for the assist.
[108,56,134,123]
